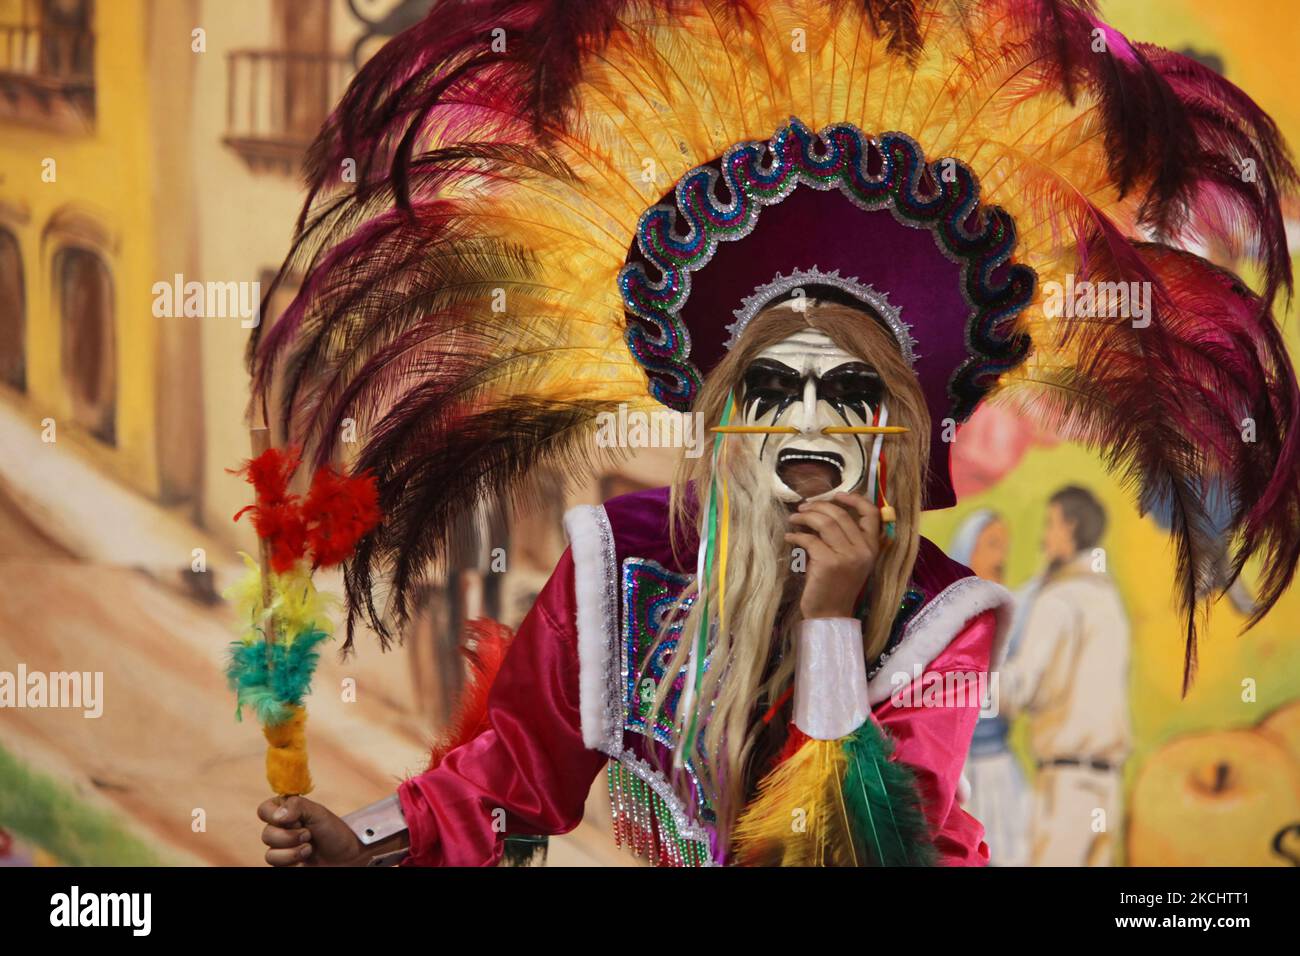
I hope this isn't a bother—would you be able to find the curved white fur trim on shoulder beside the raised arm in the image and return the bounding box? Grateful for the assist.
[867,575,1014,706]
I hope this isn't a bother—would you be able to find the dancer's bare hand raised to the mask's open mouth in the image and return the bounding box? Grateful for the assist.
[785,494,880,620]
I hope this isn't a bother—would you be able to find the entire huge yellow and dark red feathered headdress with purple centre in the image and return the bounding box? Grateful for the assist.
[251,0,1300,697]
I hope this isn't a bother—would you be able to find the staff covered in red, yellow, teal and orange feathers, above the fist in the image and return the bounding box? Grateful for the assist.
[226,428,380,796]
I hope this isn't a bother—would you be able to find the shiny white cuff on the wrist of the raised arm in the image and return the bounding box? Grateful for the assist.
[792,618,871,740]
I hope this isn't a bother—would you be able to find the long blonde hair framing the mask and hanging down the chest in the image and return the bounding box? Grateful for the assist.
[647,302,930,840]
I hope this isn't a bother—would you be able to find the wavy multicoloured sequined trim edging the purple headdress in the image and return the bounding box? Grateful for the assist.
[619,117,1035,420]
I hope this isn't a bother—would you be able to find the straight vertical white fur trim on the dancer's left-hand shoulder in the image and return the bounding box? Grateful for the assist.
[564,505,623,756]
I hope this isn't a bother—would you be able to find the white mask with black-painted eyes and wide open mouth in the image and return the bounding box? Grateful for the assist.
[740,329,884,503]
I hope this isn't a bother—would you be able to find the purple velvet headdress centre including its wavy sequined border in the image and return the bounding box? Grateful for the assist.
[619,118,1035,509]
